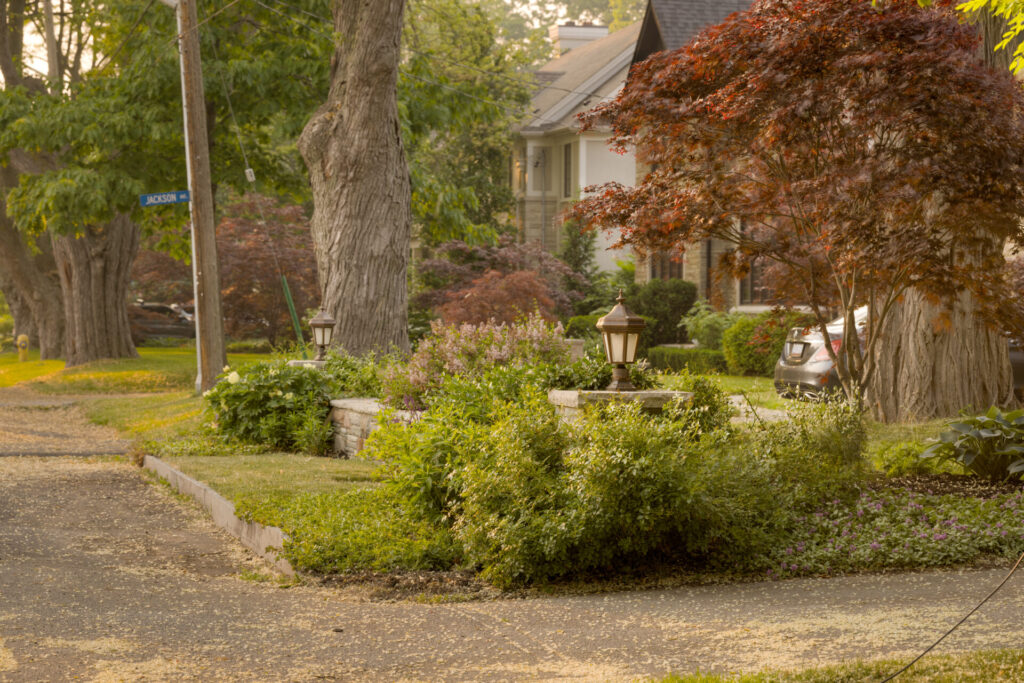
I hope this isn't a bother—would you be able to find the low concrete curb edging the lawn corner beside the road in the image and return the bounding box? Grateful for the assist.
[142,456,295,577]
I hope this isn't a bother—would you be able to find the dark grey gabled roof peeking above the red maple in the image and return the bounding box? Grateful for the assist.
[633,0,752,63]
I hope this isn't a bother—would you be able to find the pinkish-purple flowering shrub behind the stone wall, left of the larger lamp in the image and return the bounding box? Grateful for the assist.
[383,313,569,409]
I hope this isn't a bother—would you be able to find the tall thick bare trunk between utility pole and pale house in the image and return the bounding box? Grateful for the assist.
[299,0,411,353]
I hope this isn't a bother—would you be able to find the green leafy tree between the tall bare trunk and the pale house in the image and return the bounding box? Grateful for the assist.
[398,0,531,246]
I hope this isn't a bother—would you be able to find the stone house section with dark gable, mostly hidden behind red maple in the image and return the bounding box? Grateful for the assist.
[633,0,770,311]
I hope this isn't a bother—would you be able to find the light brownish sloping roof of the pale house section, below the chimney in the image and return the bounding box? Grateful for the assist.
[520,22,640,132]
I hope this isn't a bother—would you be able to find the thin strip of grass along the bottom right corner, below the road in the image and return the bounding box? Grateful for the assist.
[660,649,1024,683]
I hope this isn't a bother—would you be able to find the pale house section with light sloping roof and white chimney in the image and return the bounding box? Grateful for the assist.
[511,23,640,270]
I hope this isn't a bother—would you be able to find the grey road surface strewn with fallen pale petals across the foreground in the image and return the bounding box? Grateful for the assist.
[0,389,1024,682]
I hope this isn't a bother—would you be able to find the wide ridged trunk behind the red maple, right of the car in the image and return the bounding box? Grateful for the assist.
[867,13,1015,422]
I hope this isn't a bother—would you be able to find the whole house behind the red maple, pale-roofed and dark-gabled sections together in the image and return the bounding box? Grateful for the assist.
[512,0,768,310]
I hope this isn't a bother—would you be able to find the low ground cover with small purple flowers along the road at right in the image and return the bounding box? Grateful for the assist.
[767,489,1024,575]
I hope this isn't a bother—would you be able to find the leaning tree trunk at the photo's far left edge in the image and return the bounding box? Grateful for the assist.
[0,167,65,359]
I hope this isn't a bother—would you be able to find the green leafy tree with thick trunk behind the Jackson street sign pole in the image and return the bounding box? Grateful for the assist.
[0,0,331,365]
